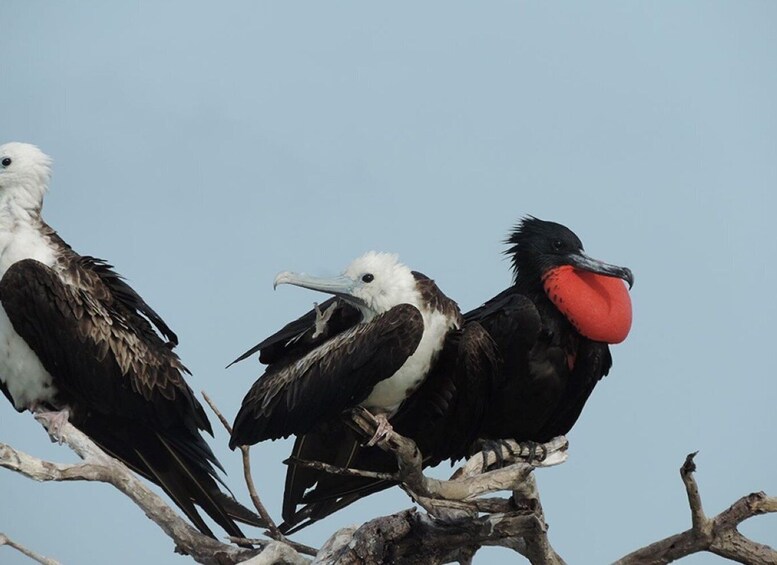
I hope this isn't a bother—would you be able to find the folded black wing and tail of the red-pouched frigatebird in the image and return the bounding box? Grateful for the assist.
[282,322,499,534]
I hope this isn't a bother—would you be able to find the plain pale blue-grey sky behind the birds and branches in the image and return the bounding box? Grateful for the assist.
[0,4,777,564]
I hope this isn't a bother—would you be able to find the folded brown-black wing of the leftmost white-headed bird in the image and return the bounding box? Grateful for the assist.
[2,259,210,432]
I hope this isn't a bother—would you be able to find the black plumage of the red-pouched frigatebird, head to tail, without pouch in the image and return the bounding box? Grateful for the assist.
[272,218,633,532]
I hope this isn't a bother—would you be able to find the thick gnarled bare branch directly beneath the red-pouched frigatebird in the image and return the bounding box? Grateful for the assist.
[300,410,567,565]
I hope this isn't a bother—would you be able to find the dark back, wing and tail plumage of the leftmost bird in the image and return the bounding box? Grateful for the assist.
[0,256,264,537]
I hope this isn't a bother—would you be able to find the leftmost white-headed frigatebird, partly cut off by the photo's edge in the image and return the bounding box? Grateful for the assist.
[0,143,264,537]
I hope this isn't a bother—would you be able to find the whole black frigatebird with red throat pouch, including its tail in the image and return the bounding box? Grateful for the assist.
[272,217,634,532]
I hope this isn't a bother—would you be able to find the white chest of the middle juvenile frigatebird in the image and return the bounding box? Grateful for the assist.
[362,311,453,414]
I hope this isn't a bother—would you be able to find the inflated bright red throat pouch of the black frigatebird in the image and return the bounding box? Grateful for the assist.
[542,265,631,343]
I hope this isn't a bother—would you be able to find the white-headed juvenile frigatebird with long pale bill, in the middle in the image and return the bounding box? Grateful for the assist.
[230,251,461,447]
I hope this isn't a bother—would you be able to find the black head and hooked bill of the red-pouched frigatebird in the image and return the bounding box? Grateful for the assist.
[505,216,634,287]
